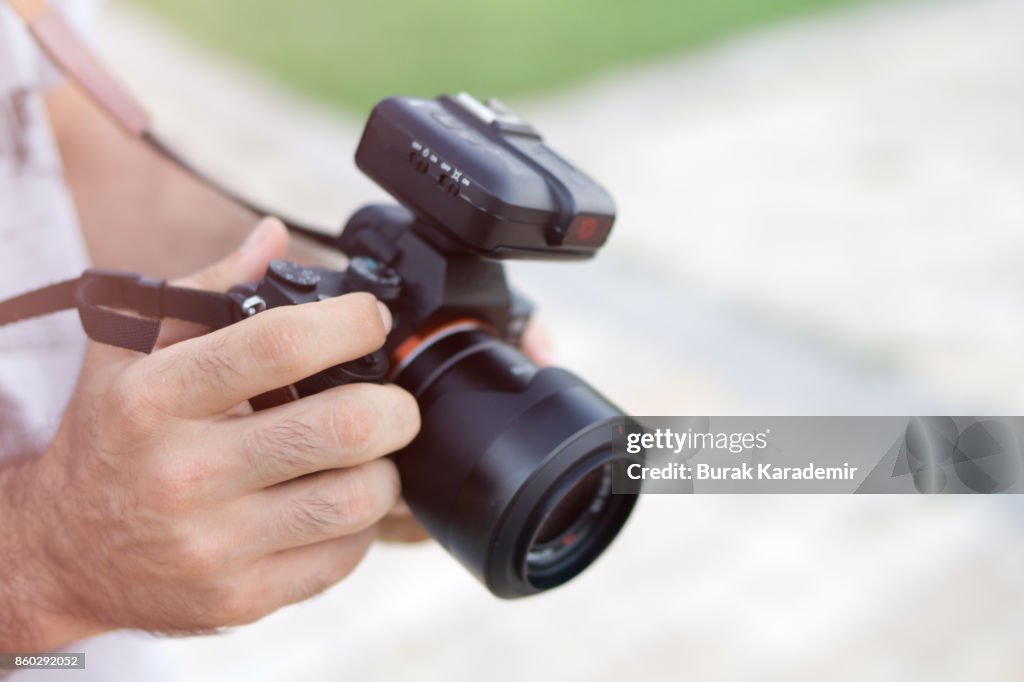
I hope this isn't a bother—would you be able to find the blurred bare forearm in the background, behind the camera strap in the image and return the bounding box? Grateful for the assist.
[47,86,327,278]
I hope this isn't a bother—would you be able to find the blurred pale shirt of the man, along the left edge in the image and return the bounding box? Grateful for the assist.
[0,0,178,682]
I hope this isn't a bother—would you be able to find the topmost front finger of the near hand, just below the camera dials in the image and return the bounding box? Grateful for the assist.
[128,293,390,418]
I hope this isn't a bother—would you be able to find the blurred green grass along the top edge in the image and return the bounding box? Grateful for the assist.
[123,0,868,113]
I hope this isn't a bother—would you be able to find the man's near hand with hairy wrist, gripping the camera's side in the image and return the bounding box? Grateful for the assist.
[0,221,419,650]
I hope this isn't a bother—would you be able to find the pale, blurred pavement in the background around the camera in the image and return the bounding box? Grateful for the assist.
[96,0,1024,681]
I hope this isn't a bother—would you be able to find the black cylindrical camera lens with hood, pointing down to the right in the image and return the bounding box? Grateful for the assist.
[395,324,636,598]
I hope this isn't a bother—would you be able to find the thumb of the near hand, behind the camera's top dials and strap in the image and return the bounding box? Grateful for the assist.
[157,218,288,348]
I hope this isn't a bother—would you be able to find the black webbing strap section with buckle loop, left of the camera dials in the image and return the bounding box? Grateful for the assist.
[0,269,237,353]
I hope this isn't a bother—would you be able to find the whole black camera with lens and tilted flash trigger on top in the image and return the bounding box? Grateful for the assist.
[231,95,636,598]
